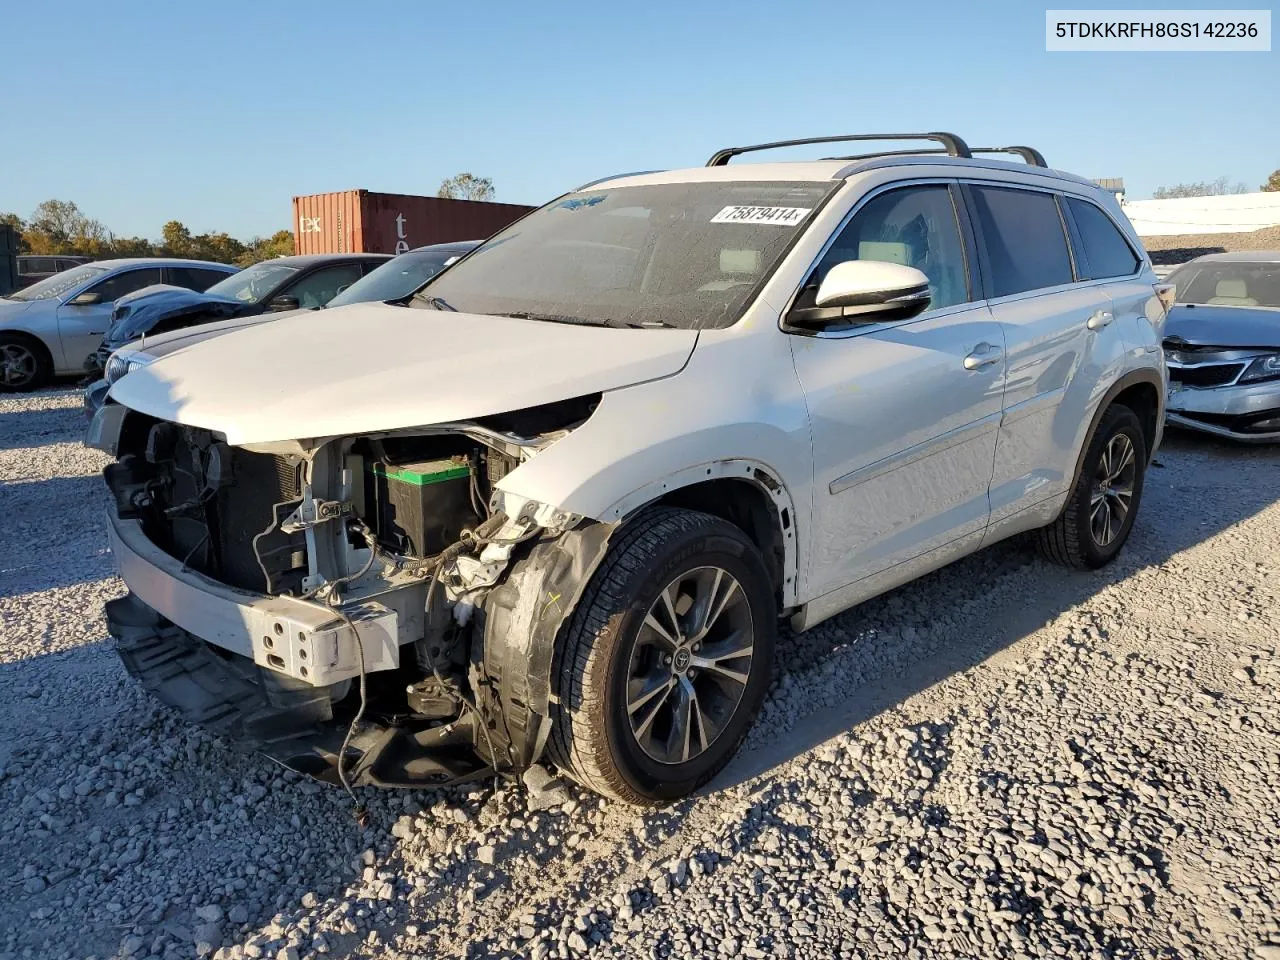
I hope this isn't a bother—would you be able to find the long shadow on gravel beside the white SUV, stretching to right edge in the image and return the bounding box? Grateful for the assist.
[701,433,1280,794]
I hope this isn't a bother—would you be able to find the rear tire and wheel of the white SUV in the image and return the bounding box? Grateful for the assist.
[1037,403,1147,570]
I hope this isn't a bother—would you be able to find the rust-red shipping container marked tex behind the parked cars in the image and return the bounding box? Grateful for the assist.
[293,189,534,253]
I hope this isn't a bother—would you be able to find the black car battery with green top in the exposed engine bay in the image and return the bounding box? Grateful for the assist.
[366,457,479,557]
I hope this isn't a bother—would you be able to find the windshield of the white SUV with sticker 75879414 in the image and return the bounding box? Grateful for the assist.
[415,182,838,329]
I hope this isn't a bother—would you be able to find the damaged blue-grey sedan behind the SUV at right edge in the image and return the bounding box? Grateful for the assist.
[1165,251,1280,443]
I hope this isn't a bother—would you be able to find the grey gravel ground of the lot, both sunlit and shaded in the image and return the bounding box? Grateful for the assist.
[0,389,1280,960]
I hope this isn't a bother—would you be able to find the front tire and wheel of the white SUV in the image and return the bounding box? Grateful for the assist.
[548,507,777,805]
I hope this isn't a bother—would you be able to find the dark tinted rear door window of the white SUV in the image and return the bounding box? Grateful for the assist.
[972,187,1074,297]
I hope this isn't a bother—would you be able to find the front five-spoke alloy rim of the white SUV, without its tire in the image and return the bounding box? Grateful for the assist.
[626,567,755,764]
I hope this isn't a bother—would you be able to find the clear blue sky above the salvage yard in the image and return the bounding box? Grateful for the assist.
[0,0,1280,237]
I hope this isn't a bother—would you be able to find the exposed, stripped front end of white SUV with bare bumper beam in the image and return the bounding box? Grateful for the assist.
[90,394,613,786]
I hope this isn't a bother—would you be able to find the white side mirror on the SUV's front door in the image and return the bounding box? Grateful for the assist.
[787,260,931,329]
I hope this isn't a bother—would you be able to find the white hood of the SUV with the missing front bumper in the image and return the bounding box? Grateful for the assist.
[111,303,698,444]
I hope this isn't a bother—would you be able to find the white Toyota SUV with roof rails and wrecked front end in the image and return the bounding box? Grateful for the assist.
[90,133,1166,803]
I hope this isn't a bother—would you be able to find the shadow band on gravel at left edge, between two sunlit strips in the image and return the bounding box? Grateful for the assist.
[0,476,114,598]
